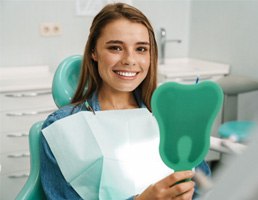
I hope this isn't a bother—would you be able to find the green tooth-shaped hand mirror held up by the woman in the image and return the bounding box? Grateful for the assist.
[151,81,223,171]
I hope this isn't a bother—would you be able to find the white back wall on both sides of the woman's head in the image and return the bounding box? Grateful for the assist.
[0,0,190,70]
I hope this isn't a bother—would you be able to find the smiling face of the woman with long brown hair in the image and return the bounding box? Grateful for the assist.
[92,19,150,92]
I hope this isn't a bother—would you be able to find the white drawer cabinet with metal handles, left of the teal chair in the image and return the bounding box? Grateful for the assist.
[0,66,56,200]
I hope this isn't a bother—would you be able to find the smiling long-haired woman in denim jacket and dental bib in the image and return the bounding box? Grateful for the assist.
[40,3,209,200]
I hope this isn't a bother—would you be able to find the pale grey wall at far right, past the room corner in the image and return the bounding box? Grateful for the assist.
[189,0,258,120]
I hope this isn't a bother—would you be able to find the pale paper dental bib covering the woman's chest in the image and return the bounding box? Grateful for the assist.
[42,108,173,200]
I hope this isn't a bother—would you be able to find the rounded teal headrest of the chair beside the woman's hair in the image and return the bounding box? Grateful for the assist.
[52,55,82,108]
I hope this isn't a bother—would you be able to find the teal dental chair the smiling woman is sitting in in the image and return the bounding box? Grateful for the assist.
[16,55,82,200]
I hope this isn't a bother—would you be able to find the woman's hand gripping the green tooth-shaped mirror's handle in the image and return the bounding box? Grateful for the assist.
[135,171,194,200]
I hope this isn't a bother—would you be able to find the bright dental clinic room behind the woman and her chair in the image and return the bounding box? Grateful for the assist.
[0,0,258,200]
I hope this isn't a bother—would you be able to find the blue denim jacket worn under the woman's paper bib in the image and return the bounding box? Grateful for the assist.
[40,93,210,200]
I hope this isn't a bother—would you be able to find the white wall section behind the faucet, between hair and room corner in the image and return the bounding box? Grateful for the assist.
[133,0,191,58]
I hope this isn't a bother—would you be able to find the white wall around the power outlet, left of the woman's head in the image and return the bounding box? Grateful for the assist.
[1,0,92,71]
